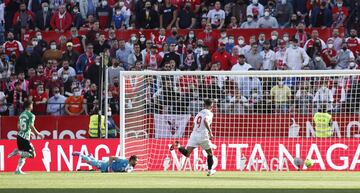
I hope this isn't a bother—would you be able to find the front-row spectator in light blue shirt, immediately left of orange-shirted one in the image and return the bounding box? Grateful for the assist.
[46,87,66,116]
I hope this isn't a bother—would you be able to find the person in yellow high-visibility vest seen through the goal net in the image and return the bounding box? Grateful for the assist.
[314,105,332,138]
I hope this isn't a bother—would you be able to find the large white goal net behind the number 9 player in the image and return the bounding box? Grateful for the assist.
[120,71,360,171]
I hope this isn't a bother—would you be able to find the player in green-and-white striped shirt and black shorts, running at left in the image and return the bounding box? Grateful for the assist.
[8,101,44,174]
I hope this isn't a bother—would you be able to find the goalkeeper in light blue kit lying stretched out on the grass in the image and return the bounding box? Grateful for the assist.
[72,152,137,172]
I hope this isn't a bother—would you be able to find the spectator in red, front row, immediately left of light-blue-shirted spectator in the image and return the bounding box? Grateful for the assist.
[29,84,49,115]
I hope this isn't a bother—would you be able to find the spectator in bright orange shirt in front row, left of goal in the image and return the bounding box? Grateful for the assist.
[65,87,87,116]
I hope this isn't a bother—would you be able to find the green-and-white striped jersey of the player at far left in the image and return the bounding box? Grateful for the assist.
[18,110,35,140]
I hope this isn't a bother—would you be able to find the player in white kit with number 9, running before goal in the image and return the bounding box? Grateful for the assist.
[170,99,216,176]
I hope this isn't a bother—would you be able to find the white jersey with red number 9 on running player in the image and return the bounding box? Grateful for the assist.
[193,109,214,136]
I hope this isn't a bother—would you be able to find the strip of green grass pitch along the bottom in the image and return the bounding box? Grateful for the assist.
[0,172,360,193]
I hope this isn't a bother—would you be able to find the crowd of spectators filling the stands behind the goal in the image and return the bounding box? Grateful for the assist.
[0,0,360,115]
